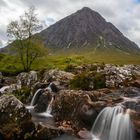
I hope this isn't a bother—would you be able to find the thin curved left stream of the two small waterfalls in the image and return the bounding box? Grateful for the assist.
[30,89,44,106]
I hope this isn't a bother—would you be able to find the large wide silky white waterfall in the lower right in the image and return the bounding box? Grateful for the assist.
[91,106,134,140]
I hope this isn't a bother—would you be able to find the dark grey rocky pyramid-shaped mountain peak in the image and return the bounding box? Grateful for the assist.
[39,7,140,53]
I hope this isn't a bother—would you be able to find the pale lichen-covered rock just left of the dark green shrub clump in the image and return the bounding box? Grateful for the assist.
[43,69,74,89]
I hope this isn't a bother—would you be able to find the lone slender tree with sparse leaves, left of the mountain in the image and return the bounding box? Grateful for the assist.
[7,7,45,71]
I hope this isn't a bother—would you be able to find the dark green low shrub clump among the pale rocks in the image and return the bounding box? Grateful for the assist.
[70,72,106,90]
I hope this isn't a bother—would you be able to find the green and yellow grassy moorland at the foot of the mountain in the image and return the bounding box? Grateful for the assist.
[0,48,140,74]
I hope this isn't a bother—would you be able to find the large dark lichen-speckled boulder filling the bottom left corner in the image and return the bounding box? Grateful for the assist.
[0,95,35,140]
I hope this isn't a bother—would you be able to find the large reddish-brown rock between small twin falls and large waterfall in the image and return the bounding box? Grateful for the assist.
[52,90,106,131]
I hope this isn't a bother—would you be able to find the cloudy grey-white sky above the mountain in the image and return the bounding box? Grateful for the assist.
[0,0,140,47]
